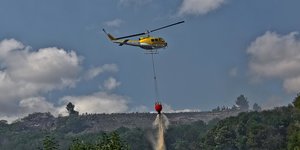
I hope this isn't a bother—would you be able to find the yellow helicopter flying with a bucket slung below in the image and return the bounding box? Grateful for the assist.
[103,21,184,53]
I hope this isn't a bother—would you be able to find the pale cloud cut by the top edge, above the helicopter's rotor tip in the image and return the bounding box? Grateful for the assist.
[178,0,226,16]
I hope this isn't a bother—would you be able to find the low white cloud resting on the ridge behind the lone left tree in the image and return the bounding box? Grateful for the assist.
[60,92,128,113]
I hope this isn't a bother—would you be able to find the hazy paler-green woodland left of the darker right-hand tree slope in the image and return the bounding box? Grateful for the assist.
[0,118,218,150]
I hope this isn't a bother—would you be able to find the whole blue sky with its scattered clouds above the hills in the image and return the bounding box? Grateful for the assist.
[0,0,300,121]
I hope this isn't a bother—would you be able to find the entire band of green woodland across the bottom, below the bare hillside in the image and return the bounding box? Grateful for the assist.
[0,95,300,150]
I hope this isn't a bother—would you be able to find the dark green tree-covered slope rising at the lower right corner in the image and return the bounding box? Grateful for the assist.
[200,106,300,150]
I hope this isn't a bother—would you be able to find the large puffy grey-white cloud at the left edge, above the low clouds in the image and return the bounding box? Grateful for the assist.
[0,39,81,101]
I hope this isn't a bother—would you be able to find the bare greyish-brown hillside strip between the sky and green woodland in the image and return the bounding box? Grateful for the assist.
[2,110,241,133]
